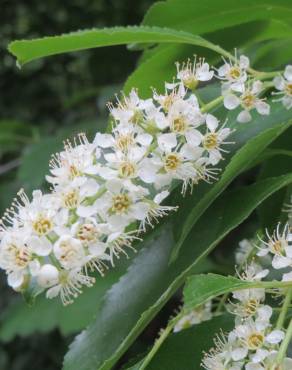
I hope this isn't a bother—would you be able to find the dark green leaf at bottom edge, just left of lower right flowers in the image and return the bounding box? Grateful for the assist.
[127,315,234,370]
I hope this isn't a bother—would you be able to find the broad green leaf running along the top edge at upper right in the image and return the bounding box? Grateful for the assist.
[143,0,292,35]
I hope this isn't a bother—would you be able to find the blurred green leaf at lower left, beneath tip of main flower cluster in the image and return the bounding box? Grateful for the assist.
[0,260,126,342]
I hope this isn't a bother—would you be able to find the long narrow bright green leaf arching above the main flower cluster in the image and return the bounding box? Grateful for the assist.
[8,26,216,65]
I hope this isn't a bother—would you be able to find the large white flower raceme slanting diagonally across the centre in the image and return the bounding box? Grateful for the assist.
[0,55,292,305]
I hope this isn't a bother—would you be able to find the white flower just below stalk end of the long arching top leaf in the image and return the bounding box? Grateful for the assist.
[217,53,249,92]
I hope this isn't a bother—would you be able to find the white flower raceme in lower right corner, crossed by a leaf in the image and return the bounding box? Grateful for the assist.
[173,206,292,370]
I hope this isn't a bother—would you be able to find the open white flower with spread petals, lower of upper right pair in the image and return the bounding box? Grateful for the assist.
[224,81,270,123]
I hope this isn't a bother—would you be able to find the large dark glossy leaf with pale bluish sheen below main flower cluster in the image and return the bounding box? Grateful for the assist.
[63,175,292,370]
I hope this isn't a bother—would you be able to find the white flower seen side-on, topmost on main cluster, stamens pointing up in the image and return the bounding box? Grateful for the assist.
[176,57,214,90]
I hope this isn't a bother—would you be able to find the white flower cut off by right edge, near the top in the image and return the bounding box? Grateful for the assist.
[274,65,292,109]
